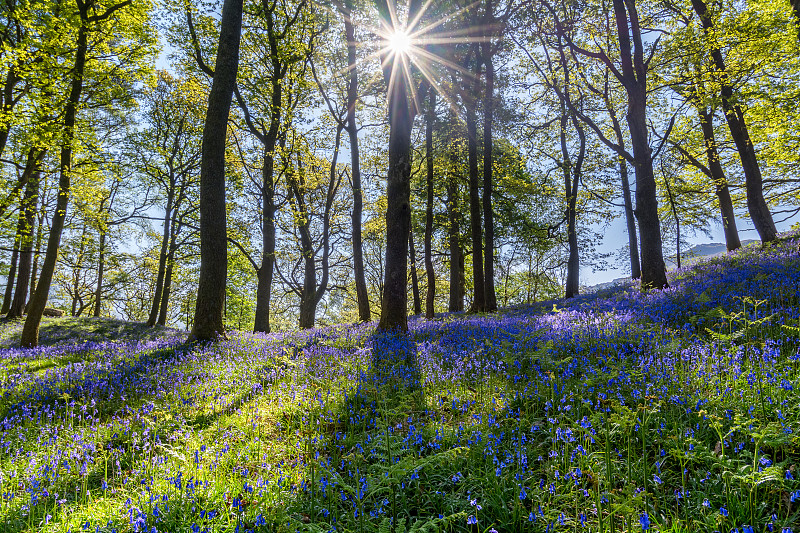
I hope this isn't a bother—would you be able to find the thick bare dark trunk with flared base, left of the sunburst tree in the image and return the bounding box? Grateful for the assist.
[189,0,243,341]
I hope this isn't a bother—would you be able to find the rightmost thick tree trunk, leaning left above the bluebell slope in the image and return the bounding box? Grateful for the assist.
[692,0,778,243]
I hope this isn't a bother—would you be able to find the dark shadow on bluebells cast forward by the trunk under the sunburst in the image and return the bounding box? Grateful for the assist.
[286,331,450,532]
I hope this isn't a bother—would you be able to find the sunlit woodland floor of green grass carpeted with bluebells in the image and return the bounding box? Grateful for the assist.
[0,236,800,533]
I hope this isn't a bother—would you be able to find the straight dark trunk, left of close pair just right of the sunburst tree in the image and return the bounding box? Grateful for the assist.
[465,95,486,313]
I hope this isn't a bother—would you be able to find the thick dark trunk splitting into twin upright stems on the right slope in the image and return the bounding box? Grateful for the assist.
[613,0,667,289]
